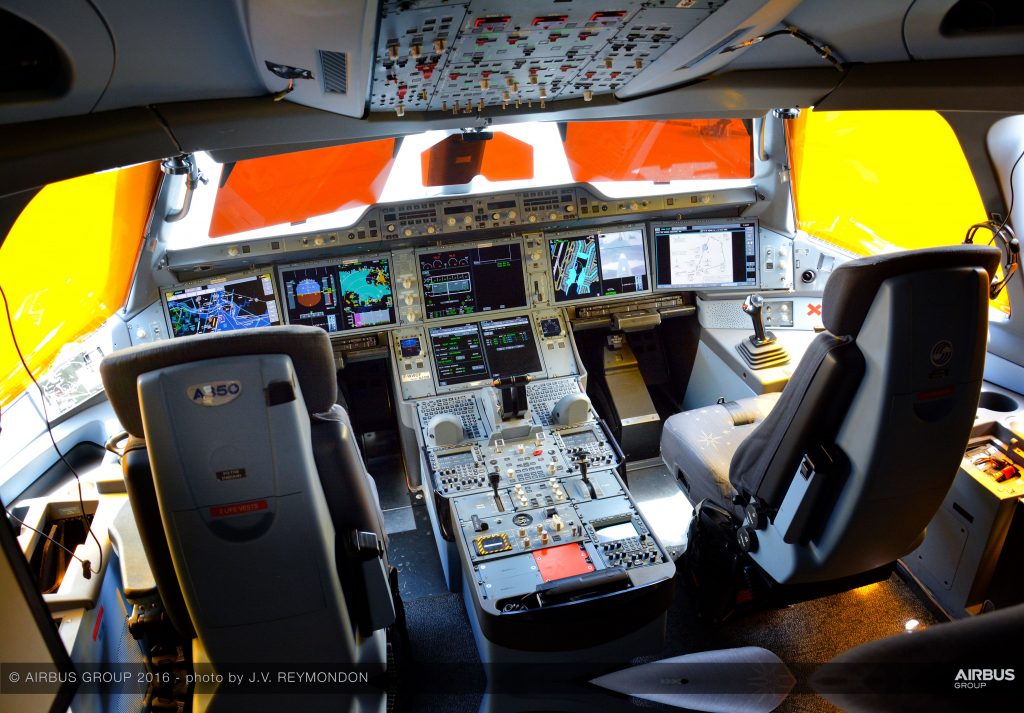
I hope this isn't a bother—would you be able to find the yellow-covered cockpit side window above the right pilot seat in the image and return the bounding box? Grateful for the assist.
[786,110,1010,314]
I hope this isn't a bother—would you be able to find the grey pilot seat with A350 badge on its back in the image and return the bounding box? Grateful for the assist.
[100,326,400,667]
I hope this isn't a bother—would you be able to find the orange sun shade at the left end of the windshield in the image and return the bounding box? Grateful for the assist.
[210,138,394,238]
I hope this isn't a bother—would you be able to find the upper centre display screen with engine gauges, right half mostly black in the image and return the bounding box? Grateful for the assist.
[419,243,526,320]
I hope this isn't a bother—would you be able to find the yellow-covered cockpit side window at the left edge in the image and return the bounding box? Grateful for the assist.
[0,163,160,405]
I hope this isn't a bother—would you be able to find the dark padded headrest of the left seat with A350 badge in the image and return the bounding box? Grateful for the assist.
[99,326,338,438]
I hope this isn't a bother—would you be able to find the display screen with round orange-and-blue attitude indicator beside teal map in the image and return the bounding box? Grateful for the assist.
[281,257,395,332]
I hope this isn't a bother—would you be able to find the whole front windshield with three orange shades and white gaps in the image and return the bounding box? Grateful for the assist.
[165,119,754,249]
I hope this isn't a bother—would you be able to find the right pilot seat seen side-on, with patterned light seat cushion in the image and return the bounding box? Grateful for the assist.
[662,245,999,600]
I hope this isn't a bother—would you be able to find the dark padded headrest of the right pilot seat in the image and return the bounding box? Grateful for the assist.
[821,245,1000,337]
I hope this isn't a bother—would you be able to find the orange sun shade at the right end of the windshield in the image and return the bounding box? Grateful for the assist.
[565,119,754,182]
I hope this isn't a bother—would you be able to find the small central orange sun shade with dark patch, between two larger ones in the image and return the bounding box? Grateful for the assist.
[420,131,534,186]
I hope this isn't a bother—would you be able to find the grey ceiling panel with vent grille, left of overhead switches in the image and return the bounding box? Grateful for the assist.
[246,0,378,118]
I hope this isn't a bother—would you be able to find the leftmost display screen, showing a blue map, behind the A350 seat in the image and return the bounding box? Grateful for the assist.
[164,272,281,337]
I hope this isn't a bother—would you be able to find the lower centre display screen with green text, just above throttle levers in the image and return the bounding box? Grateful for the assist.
[430,317,541,386]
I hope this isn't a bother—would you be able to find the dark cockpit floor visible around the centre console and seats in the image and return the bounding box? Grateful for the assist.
[385,464,940,713]
